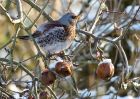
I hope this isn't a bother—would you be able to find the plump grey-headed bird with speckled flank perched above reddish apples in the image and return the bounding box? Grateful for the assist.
[18,12,80,54]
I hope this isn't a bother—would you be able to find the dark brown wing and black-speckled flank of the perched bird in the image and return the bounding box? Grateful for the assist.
[33,24,67,45]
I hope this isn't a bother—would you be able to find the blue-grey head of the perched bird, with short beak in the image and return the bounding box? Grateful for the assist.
[59,12,80,26]
